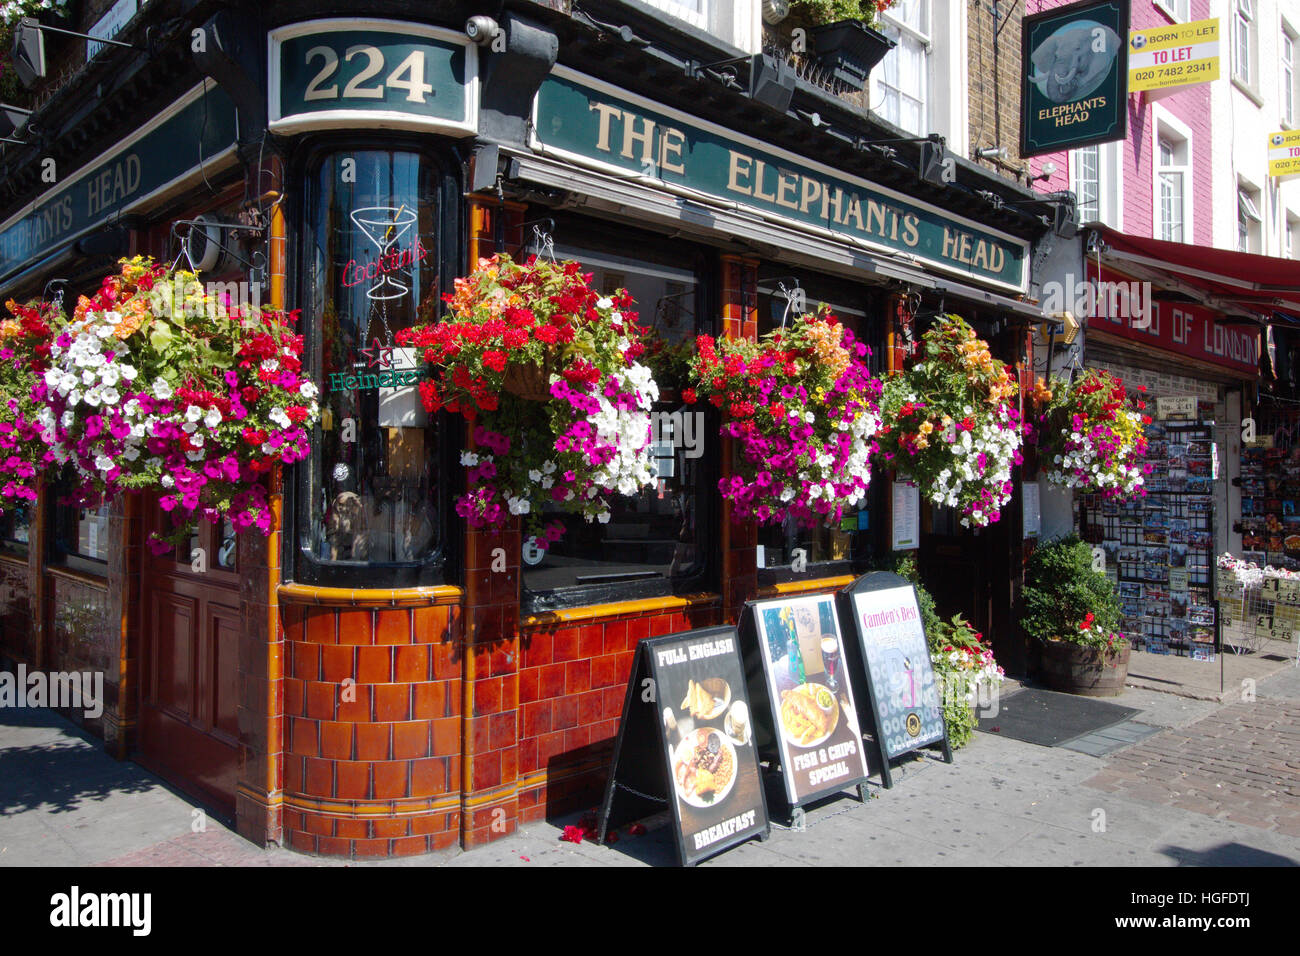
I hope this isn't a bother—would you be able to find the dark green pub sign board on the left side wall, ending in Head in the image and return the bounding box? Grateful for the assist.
[0,83,238,287]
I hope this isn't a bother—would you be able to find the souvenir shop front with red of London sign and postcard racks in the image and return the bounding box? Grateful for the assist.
[1075,230,1279,658]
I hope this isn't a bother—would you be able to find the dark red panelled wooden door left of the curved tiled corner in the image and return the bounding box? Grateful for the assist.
[138,505,242,817]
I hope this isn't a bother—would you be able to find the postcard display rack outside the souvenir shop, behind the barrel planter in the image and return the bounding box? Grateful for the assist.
[1075,420,1218,661]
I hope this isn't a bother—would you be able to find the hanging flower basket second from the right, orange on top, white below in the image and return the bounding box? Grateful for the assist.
[876,315,1023,528]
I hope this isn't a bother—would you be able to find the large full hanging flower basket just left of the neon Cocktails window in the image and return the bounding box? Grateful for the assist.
[31,256,319,553]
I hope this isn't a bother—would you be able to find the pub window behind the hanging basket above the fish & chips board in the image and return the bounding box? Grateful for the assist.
[758,270,883,584]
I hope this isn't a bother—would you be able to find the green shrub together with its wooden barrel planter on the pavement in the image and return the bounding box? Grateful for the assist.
[1021,535,1130,697]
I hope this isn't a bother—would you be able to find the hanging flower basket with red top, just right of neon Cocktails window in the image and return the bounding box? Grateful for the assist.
[398,255,659,548]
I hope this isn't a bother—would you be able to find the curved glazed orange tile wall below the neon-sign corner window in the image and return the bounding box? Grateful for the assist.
[281,605,462,857]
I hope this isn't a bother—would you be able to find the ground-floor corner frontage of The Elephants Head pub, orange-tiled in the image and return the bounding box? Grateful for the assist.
[0,3,1050,856]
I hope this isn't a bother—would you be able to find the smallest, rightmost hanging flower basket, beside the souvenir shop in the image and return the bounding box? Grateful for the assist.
[1036,369,1151,498]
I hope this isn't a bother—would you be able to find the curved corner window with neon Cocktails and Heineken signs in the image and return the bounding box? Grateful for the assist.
[294,150,458,587]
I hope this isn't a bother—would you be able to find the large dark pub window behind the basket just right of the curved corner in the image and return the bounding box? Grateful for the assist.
[524,222,718,610]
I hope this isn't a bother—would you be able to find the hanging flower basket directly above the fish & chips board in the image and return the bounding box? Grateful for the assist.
[683,310,880,527]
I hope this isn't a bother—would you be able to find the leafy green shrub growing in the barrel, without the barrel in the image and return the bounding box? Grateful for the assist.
[1021,535,1119,644]
